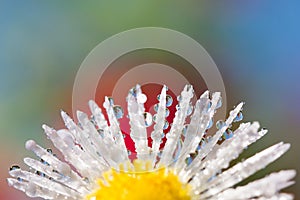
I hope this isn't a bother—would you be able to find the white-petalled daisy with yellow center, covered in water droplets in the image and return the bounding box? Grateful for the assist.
[7,85,295,200]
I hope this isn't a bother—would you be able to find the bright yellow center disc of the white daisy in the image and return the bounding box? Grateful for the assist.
[87,161,191,200]
